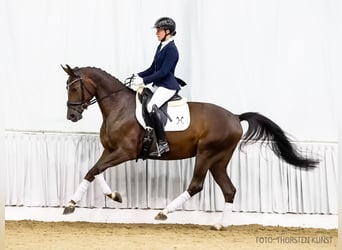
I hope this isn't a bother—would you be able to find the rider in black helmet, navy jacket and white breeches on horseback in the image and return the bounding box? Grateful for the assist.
[132,17,180,157]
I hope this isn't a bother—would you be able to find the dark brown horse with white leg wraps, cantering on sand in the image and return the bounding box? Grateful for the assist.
[61,65,319,229]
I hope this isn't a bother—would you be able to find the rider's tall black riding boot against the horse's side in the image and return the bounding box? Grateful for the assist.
[150,105,170,157]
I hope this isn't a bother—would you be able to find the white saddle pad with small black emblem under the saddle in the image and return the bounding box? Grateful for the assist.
[135,93,190,131]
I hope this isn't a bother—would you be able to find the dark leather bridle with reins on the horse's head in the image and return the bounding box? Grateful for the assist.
[67,73,132,114]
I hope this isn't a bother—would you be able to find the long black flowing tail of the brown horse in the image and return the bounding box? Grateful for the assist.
[238,112,319,168]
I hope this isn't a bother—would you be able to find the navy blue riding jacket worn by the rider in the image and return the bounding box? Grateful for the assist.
[138,41,180,90]
